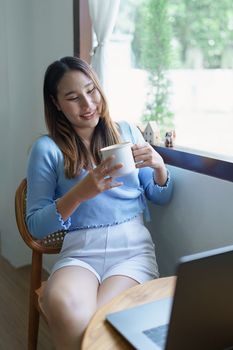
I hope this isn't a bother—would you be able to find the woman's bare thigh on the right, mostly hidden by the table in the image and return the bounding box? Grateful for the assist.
[97,275,139,309]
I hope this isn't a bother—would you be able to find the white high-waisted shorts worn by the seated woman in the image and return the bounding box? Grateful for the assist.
[51,215,159,283]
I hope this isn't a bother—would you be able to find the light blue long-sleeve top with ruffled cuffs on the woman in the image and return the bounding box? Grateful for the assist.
[27,122,173,238]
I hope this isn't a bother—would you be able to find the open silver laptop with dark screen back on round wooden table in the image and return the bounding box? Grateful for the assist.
[106,245,233,350]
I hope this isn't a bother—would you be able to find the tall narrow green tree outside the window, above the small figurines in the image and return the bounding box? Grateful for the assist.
[132,0,173,135]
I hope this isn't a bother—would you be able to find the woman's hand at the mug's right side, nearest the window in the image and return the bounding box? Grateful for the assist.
[132,142,165,169]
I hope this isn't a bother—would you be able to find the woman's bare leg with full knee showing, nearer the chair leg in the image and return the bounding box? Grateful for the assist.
[42,266,99,350]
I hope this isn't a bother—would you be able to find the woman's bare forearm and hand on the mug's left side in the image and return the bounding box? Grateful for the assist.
[56,156,123,221]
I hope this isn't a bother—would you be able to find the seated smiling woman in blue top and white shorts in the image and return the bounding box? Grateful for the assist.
[27,57,172,350]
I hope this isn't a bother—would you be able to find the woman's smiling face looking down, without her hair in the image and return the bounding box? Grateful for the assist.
[54,71,102,135]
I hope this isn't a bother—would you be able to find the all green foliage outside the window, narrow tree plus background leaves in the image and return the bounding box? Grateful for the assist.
[132,0,233,133]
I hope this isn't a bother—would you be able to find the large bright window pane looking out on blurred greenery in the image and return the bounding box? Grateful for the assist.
[108,0,233,160]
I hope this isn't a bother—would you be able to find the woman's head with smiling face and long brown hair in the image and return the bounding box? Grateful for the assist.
[44,57,119,177]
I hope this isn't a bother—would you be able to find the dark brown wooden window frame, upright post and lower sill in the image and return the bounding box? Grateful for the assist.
[73,0,233,182]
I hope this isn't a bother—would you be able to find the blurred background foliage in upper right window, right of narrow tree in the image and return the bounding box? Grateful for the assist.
[170,0,233,69]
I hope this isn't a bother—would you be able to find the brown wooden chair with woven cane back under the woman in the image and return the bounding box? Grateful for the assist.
[15,179,66,350]
